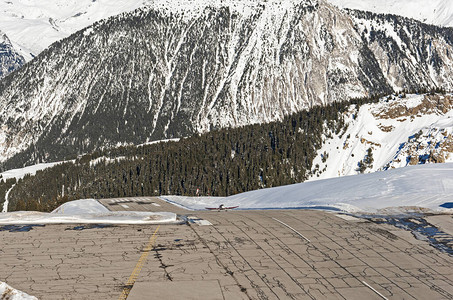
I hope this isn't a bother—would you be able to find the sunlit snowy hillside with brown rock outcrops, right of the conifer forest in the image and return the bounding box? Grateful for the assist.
[311,94,453,180]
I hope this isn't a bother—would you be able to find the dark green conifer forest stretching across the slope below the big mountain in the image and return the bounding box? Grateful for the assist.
[0,96,379,211]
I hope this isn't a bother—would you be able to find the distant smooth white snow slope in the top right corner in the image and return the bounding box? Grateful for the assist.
[327,0,453,27]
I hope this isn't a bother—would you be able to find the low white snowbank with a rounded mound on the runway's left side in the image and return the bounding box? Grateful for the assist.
[0,199,177,225]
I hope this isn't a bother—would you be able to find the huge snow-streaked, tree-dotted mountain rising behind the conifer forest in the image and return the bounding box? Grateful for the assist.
[0,0,453,169]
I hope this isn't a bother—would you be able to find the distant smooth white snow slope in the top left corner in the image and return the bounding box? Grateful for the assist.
[0,0,150,61]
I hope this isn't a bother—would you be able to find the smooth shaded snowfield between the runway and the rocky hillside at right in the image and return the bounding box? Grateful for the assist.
[161,163,453,214]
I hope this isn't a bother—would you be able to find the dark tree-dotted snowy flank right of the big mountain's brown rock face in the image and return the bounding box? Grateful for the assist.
[349,11,453,90]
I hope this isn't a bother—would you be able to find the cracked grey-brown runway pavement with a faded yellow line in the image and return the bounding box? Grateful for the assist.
[0,198,453,299]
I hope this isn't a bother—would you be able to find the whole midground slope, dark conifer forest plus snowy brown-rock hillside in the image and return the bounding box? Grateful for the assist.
[0,94,453,211]
